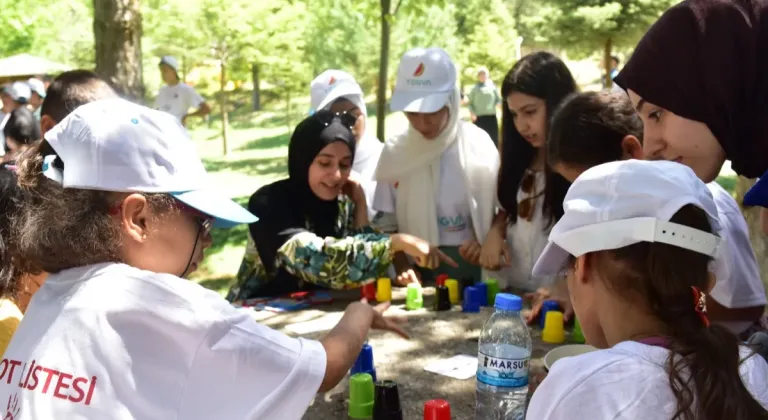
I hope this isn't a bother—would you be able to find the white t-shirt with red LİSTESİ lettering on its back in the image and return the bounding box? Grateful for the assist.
[0,264,326,420]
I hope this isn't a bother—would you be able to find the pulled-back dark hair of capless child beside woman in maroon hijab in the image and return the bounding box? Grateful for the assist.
[547,91,643,169]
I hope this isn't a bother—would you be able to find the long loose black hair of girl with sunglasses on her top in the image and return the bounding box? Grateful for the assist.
[496,51,578,225]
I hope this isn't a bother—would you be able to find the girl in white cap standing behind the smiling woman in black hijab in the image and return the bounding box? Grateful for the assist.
[310,70,384,221]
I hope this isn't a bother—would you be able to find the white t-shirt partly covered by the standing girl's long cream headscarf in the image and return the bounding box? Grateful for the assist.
[373,142,475,246]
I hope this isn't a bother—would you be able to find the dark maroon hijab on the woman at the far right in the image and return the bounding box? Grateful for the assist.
[615,0,768,178]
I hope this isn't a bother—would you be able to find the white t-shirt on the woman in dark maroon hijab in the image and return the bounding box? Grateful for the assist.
[707,182,766,312]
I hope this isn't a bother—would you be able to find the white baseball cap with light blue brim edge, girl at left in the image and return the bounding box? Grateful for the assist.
[43,98,258,228]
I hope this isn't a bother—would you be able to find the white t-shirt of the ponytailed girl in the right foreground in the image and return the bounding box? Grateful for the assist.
[526,341,768,420]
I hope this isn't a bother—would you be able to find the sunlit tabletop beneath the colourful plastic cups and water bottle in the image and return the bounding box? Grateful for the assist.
[254,287,568,420]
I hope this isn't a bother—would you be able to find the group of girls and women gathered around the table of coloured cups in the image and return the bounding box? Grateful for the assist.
[0,0,768,420]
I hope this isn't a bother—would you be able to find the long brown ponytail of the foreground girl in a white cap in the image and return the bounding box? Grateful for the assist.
[592,204,768,420]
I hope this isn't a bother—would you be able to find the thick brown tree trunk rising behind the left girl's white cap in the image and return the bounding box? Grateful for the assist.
[93,0,144,103]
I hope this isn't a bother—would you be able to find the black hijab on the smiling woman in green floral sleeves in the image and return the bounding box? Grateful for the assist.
[248,111,356,274]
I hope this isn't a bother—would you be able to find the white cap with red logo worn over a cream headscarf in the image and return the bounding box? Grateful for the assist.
[390,48,456,113]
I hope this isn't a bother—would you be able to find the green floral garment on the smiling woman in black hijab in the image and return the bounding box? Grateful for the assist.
[227,196,391,301]
